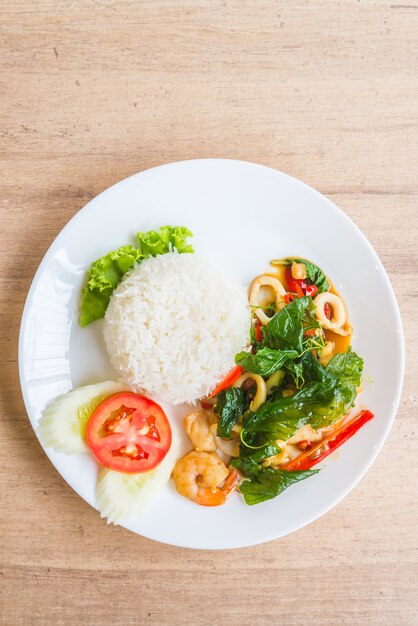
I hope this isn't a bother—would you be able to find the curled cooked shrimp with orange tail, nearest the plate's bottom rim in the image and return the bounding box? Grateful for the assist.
[173,451,240,506]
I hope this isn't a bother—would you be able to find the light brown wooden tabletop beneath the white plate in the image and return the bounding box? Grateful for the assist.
[0,0,418,626]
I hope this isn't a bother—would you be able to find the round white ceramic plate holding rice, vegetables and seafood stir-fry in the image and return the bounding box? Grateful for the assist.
[19,159,404,549]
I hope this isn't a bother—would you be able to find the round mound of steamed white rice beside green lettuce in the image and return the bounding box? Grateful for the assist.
[104,252,250,404]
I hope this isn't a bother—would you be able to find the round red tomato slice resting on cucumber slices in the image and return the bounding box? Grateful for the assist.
[86,391,172,474]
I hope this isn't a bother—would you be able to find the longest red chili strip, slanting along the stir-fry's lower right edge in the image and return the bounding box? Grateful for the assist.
[280,410,374,471]
